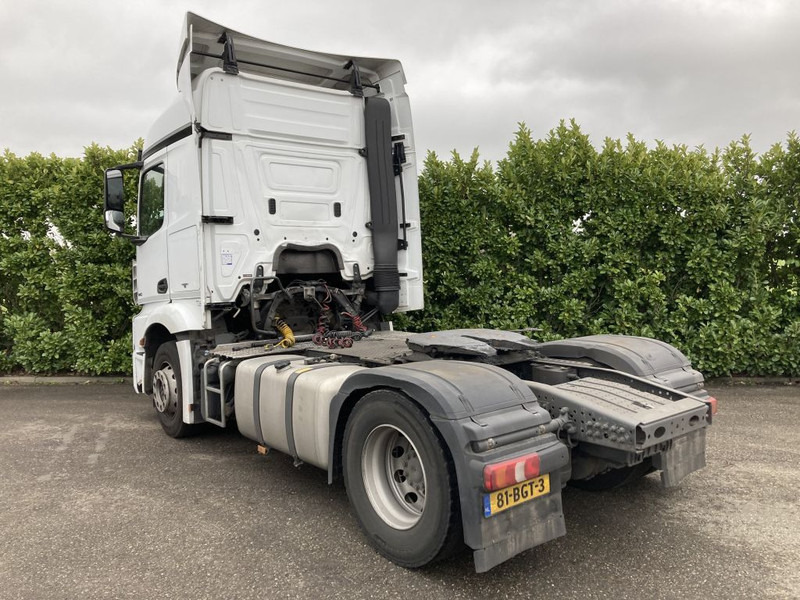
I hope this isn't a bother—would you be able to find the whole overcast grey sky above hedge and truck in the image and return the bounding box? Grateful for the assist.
[0,0,800,160]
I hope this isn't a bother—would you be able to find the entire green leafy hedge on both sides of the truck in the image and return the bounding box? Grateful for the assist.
[0,123,800,376]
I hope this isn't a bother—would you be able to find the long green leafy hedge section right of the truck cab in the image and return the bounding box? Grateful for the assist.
[401,122,800,376]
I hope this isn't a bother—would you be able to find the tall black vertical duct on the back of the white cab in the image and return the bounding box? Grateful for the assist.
[364,96,400,315]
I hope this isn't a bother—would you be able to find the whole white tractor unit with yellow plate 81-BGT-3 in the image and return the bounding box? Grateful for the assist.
[104,13,716,572]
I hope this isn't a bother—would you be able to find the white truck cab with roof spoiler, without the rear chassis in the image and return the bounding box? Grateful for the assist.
[106,14,422,406]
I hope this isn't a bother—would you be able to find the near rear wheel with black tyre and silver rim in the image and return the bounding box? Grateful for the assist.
[342,390,463,568]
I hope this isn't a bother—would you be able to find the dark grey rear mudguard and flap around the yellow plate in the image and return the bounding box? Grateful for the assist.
[329,360,570,572]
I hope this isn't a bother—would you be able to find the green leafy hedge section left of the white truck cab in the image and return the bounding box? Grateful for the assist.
[0,145,136,374]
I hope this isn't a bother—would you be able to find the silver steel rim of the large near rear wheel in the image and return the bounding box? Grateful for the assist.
[361,425,427,530]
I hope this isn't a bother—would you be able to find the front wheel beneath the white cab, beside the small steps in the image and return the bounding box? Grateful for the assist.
[153,342,196,438]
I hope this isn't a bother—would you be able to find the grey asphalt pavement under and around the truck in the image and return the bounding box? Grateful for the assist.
[0,384,800,600]
